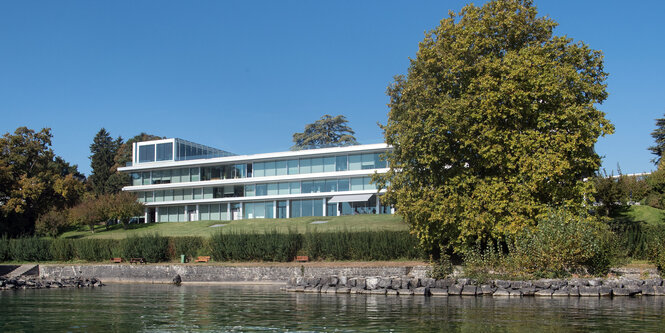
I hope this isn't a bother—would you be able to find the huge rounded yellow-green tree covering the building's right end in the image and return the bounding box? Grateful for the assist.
[379,0,613,256]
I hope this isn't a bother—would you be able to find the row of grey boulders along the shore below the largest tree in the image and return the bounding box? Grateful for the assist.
[283,275,665,297]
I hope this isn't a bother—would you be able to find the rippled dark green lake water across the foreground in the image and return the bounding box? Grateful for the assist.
[0,284,665,332]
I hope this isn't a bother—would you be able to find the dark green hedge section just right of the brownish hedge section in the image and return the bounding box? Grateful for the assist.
[210,231,302,261]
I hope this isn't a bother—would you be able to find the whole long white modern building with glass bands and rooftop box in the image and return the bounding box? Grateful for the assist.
[119,138,393,222]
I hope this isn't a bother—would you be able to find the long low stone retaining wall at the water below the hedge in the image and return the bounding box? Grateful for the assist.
[39,264,427,283]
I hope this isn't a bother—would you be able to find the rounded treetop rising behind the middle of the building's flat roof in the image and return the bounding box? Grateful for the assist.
[291,114,358,150]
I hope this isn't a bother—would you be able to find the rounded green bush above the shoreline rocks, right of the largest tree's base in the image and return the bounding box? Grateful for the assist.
[512,210,616,277]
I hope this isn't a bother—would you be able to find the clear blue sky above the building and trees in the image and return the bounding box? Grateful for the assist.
[0,0,665,174]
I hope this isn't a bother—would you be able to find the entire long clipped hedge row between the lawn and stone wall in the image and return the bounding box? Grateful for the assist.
[0,231,425,262]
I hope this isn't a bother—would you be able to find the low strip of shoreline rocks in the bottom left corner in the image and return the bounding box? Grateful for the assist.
[0,276,104,290]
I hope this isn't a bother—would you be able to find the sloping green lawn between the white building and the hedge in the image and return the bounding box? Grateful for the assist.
[61,215,408,239]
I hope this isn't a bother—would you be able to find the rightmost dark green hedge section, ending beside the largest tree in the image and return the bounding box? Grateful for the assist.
[303,231,424,260]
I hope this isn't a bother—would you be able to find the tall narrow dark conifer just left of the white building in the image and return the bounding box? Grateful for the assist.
[88,128,122,195]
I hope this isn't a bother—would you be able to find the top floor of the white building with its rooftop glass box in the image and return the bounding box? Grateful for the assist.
[119,139,389,189]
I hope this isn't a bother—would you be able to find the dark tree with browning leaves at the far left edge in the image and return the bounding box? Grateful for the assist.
[0,127,84,235]
